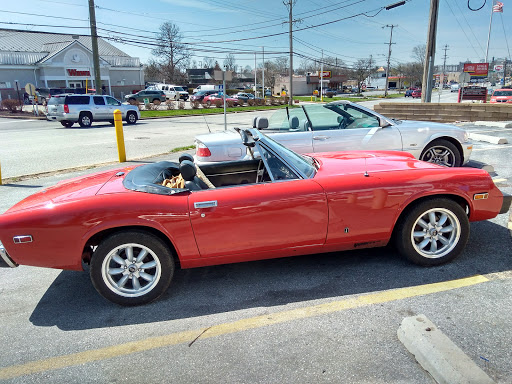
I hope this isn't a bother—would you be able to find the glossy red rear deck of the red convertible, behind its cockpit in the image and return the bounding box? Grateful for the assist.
[6,167,133,213]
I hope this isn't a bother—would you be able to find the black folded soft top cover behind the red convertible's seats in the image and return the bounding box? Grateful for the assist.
[123,161,188,195]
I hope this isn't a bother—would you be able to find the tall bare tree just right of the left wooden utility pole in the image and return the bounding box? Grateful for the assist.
[152,21,190,83]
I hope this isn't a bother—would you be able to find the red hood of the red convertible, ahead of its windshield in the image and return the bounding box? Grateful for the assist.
[313,151,443,176]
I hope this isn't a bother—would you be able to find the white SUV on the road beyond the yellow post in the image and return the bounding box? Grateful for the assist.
[46,94,140,128]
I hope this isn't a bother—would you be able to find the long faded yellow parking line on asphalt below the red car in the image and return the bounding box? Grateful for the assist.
[0,275,488,380]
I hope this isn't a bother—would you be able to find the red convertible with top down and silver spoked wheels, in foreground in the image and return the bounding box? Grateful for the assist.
[0,129,511,305]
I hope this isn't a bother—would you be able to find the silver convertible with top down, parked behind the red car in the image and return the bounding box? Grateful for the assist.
[195,101,473,167]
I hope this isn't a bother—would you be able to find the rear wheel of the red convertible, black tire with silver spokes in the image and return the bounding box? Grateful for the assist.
[90,230,175,306]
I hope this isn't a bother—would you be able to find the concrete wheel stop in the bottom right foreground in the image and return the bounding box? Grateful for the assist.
[397,315,494,384]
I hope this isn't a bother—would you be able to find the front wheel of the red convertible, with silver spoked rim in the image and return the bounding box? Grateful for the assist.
[395,198,469,266]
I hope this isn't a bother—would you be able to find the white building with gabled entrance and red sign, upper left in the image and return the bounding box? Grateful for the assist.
[0,29,144,98]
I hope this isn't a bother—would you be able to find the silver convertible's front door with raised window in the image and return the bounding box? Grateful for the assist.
[304,104,402,152]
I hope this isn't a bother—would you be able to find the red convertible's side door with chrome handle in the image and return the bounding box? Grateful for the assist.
[188,142,329,261]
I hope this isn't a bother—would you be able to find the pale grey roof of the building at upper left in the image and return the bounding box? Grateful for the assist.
[0,29,129,57]
